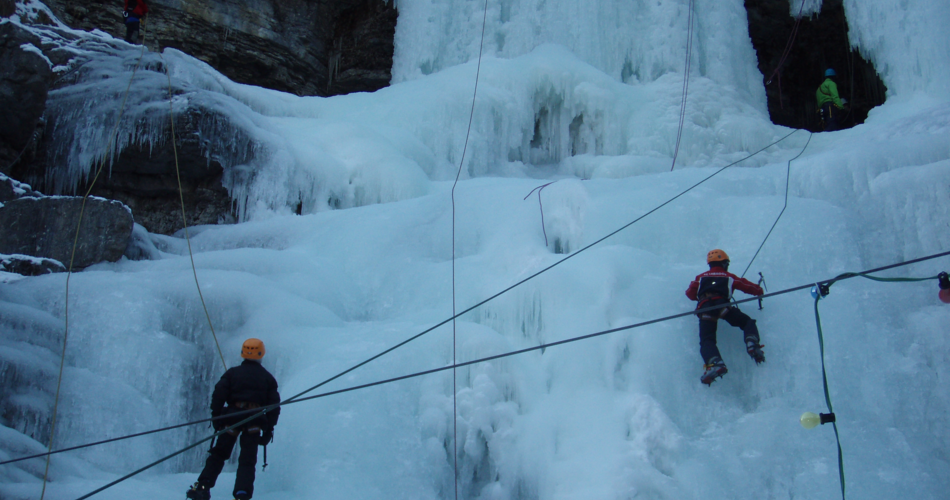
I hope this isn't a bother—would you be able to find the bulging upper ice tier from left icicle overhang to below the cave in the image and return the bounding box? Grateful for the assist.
[37,27,779,220]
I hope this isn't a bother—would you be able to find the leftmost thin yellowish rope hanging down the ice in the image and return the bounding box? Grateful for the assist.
[40,19,147,500]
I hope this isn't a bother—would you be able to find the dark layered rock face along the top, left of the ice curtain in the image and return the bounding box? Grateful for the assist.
[46,0,396,96]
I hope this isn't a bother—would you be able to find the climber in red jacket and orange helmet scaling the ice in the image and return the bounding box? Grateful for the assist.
[686,249,765,385]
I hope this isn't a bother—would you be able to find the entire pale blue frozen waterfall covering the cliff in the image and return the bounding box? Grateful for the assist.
[0,0,950,500]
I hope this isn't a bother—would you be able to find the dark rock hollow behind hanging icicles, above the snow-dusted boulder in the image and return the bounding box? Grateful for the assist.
[31,65,249,234]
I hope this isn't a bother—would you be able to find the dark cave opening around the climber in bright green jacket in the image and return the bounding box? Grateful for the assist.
[745,0,887,132]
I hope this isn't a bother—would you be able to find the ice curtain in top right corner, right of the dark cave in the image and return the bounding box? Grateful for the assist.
[844,0,950,100]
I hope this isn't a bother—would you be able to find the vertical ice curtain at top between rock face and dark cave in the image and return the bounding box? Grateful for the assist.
[393,0,765,111]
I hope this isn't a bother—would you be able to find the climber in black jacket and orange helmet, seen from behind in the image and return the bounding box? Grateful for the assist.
[186,339,280,500]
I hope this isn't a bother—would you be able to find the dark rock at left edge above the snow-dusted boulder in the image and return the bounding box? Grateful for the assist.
[0,23,52,173]
